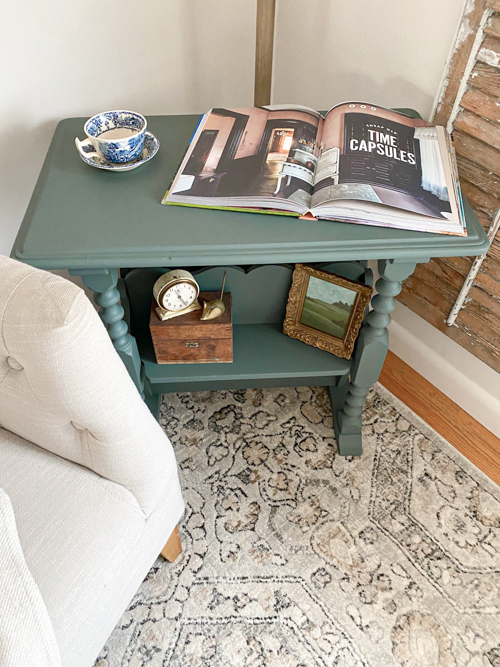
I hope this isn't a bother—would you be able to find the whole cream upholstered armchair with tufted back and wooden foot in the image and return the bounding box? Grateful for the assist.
[0,256,184,667]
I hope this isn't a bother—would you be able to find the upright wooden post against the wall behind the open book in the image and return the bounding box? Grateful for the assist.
[254,0,276,107]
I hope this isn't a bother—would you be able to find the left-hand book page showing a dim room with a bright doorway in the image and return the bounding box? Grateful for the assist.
[164,107,323,212]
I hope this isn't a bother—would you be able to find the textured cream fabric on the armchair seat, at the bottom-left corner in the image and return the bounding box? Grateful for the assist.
[0,489,61,667]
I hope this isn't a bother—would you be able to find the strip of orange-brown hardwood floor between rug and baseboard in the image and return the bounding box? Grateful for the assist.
[379,352,500,484]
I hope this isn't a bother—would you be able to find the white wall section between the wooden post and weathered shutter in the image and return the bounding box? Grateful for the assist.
[273,0,464,117]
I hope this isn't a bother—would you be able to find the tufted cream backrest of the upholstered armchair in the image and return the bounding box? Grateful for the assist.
[0,256,176,516]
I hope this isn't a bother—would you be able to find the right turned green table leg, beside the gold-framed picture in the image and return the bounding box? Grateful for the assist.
[334,259,428,456]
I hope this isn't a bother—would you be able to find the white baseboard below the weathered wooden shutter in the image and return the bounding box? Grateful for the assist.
[389,303,500,437]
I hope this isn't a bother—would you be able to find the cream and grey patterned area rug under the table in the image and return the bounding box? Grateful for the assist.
[96,385,500,667]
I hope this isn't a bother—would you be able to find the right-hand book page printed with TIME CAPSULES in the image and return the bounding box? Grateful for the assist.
[311,102,454,219]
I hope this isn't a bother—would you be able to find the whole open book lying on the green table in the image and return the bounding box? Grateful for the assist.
[162,102,467,236]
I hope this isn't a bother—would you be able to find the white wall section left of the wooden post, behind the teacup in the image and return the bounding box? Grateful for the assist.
[0,0,255,254]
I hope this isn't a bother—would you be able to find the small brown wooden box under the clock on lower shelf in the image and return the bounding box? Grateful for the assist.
[149,292,233,364]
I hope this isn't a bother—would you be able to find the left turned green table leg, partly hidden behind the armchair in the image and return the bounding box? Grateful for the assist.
[69,269,144,398]
